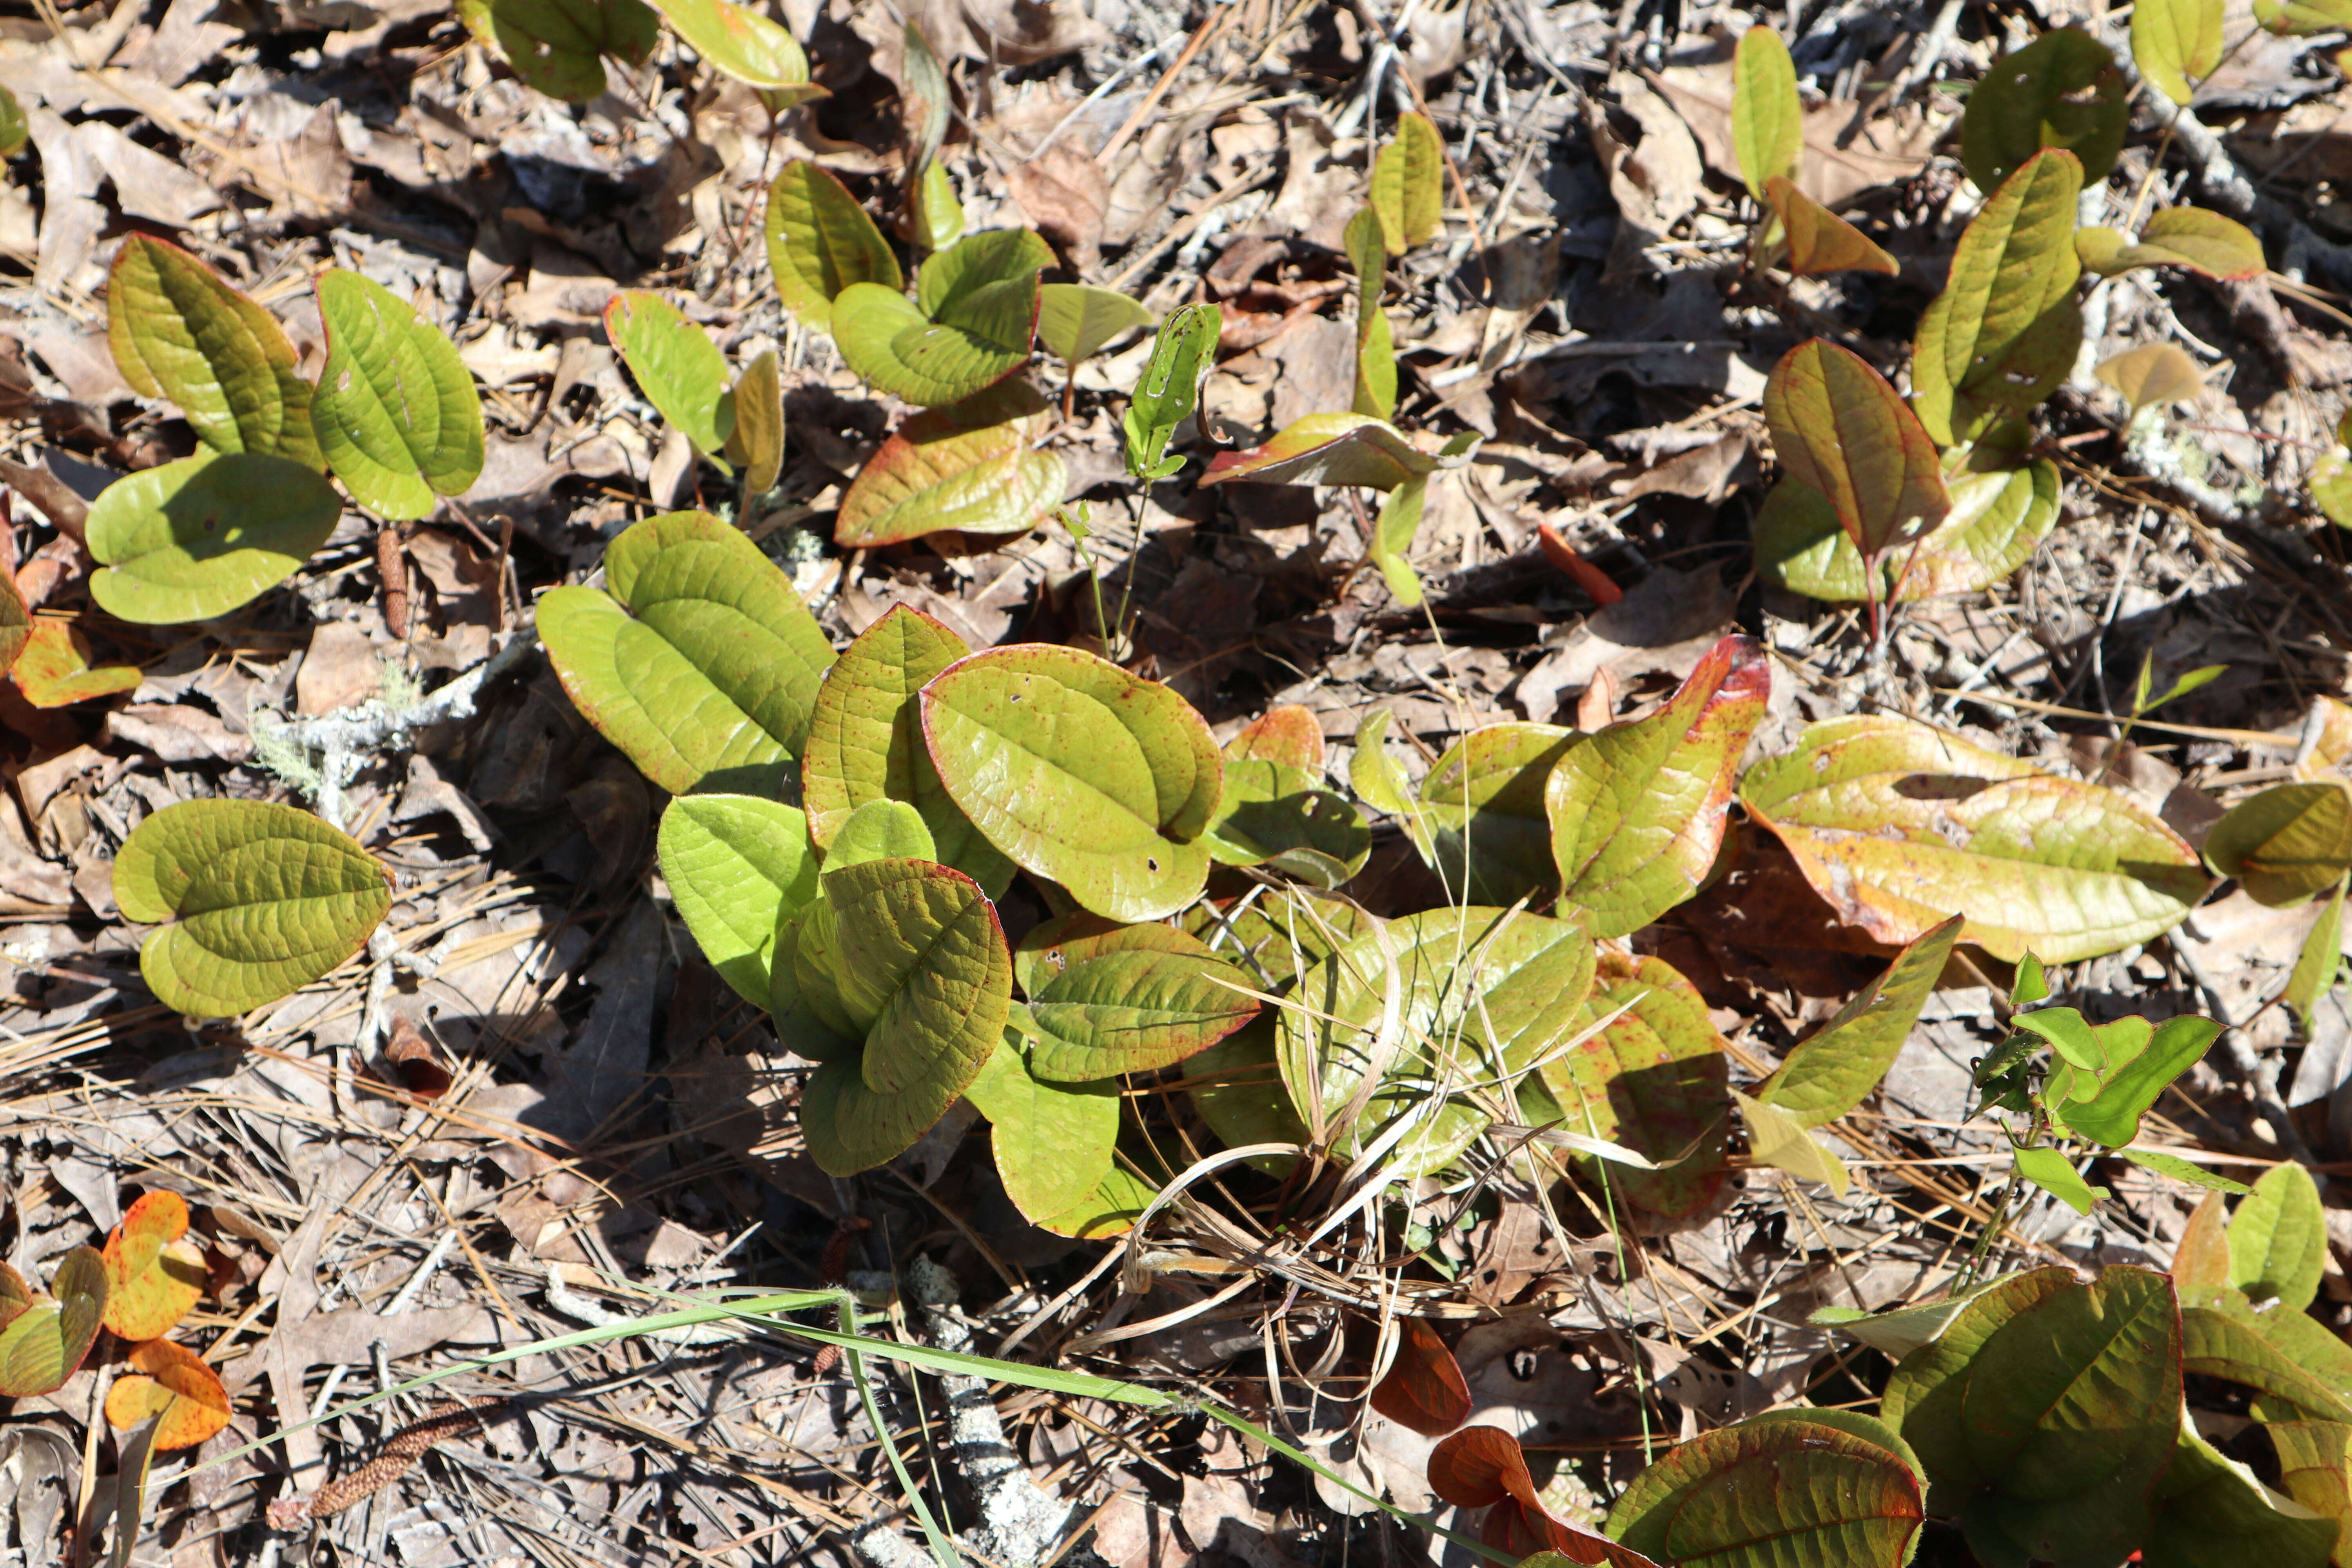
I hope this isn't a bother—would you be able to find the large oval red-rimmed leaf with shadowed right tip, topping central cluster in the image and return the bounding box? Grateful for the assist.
[922,644,1223,919]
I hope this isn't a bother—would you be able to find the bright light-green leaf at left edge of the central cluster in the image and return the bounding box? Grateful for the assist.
[659,795,816,1006]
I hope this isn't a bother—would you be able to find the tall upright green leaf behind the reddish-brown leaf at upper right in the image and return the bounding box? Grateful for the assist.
[1912,151,2084,444]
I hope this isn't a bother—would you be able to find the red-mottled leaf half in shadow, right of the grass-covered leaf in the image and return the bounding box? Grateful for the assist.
[1543,952,1731,1218]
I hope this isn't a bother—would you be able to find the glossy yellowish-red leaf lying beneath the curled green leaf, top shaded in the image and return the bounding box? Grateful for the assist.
[833,381,1070,550]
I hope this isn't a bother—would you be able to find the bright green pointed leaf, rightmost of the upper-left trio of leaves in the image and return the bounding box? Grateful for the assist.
[310,268,482,519]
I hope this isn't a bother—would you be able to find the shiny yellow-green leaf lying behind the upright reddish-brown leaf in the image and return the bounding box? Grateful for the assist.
[1755,458,2058,604]
